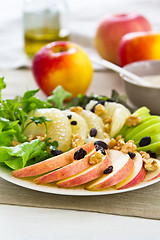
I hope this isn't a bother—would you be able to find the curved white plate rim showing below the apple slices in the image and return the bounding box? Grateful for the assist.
[0,166,160,196]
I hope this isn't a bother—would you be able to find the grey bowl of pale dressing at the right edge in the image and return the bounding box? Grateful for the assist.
[122,60,160,115]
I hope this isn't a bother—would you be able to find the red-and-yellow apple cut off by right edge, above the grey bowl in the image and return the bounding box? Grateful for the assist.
[118,32,160,67]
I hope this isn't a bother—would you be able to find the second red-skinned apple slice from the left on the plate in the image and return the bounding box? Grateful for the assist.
[34,149,96,184]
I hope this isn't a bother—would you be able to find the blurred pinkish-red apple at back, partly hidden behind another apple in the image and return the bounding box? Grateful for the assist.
[95,13,151,64]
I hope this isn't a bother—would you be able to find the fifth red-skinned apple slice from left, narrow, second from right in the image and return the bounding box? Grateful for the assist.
[116,153,146,189]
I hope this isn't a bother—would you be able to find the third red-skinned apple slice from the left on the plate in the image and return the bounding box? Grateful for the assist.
[57,154,112,188]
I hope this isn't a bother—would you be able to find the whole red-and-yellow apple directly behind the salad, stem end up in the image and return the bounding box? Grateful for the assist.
[32,41,93,96]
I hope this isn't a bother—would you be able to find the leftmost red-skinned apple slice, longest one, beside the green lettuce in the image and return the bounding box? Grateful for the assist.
[12,143,94,178]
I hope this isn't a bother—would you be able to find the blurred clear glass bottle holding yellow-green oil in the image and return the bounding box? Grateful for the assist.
[23,0,69,57]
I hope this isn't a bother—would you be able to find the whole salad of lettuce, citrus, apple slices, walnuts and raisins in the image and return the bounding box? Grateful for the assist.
[0,78,160,192]
